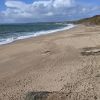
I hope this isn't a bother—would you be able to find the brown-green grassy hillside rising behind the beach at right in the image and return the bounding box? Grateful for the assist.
[74,15,100,25]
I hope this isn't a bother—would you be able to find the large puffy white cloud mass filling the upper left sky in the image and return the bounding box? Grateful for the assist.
[2,0,74,21]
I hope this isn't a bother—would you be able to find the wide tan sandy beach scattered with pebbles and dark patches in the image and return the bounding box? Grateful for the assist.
[0,25,100,100]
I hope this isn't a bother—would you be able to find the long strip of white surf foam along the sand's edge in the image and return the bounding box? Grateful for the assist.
[0,24,75,45]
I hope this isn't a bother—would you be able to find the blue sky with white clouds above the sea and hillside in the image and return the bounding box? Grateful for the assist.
[0,0,100,23]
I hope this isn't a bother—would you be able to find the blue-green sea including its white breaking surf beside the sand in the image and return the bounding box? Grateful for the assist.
[0,22,74,45]
